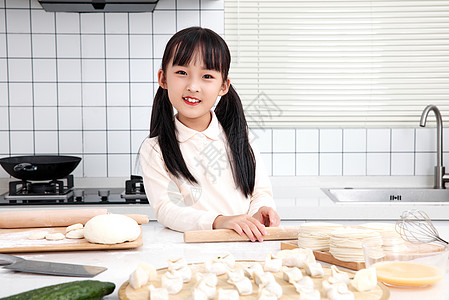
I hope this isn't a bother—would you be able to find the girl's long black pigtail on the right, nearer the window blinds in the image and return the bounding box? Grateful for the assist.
[215,85,256,197]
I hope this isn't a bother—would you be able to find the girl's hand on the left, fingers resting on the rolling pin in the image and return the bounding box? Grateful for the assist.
[212,214,267,242]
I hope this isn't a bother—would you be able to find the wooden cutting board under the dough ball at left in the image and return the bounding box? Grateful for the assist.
[0,227,143,253]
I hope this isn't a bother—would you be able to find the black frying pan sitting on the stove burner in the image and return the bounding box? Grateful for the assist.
[0,155,81,180]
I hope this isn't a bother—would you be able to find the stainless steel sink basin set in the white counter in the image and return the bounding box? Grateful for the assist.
[321,188,449,202]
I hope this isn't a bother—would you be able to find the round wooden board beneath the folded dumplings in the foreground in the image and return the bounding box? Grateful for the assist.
[118,261,390,300]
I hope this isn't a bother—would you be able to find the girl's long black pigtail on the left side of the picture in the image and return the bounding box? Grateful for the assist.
[150,87,197,183]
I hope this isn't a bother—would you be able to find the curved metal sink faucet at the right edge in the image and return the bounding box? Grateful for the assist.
[419,105,449,189]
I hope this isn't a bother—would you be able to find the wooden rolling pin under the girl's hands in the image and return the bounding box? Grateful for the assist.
[184,226,300,243]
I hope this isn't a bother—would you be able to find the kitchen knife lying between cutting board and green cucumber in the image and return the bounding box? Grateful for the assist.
[0,254,107,277]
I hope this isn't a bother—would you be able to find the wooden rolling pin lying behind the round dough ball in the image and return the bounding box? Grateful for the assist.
[0,209,149,228]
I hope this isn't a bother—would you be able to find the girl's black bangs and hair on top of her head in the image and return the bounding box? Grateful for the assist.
[162,27,231,80]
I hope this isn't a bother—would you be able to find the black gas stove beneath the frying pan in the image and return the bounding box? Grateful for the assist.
[0,175,148,206]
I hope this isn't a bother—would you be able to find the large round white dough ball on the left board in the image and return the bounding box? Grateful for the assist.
[84,214,140,244]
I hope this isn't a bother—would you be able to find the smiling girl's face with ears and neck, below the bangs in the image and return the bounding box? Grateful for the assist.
[158,55,230,131]
